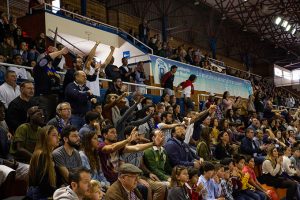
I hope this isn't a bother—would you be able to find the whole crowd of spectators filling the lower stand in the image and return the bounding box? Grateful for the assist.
[0,8,300,200]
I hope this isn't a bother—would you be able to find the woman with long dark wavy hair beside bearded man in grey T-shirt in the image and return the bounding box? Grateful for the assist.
[79,131,110,188]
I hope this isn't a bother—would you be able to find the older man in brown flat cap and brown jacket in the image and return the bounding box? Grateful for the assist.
[105,163,143,200]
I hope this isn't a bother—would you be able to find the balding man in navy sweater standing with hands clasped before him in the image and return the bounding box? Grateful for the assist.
[65,71,97,129]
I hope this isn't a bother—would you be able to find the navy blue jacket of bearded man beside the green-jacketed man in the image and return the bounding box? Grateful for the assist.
[165,137,199,167]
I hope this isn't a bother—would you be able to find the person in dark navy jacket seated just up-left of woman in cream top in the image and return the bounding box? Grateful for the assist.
[240,128,267,164]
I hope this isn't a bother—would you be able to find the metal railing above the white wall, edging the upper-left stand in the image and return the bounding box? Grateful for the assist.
[44,3,153,54]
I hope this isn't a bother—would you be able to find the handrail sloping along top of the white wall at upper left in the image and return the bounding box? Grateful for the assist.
[44,3,153,54]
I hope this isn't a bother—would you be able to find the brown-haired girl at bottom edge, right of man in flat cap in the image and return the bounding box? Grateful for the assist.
[168,166,190,200]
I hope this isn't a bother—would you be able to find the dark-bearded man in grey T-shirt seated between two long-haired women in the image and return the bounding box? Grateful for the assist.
[52,125,82,186]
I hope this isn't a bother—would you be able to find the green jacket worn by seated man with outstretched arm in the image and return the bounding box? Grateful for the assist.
[144,146,172,181]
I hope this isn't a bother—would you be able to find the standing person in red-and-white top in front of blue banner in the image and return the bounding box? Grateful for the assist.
[179,74,197,113]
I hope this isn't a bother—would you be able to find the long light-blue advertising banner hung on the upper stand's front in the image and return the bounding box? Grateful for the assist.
[149,55,253,98]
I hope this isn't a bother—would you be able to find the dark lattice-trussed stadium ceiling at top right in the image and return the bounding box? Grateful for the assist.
[195,0,300,56]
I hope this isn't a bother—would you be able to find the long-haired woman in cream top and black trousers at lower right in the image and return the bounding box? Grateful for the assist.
[260,145,300,200]
